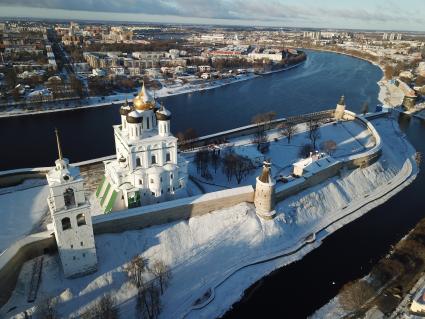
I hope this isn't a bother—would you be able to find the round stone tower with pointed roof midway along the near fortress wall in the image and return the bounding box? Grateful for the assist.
[254,161,276,219]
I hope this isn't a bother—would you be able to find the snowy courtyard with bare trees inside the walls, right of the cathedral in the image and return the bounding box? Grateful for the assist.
[183,121,375,192]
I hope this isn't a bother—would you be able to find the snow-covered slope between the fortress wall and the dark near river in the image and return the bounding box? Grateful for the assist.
[0,119,417,318]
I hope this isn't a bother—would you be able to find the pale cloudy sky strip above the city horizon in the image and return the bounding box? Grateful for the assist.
[0,0,425,31]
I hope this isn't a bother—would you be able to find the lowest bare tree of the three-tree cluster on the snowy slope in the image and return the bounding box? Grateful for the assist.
[136,282,161,319]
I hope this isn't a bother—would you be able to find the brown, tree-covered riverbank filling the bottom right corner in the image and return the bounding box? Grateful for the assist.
[312,200,425,319]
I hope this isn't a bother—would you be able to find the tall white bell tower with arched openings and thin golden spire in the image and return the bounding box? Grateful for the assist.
[46,130,97,277]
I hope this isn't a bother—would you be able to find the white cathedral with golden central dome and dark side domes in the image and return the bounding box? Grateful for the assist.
[96,84,188,213]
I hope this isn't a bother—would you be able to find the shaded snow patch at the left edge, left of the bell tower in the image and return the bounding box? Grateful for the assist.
[0,180,49,254]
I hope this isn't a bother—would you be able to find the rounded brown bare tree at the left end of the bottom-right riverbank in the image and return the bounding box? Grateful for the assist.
[339,280,375,311]
